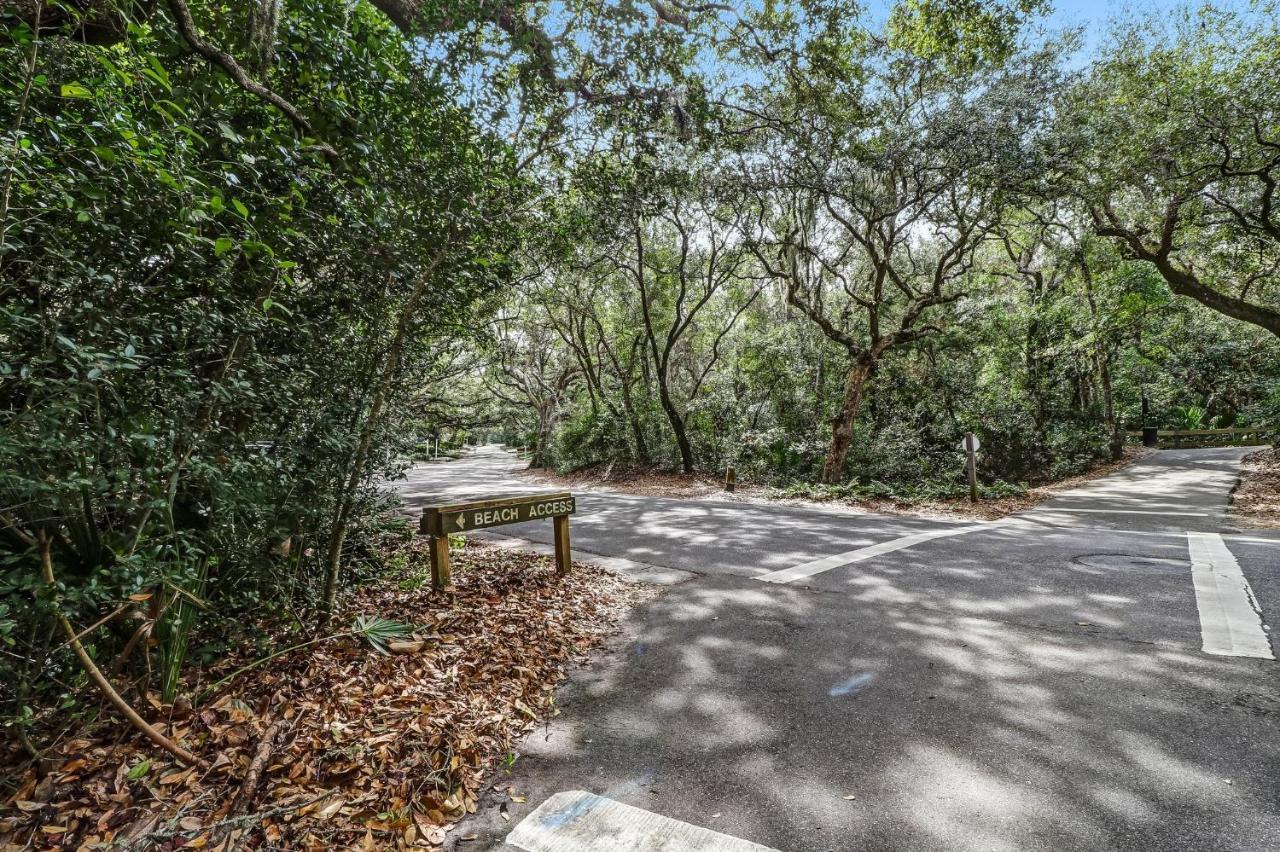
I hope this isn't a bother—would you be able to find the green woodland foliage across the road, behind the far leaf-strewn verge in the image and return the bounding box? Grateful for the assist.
[483,3,1280,493]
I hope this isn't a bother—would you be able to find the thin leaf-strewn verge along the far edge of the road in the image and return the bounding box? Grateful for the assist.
[526,446,1151,521]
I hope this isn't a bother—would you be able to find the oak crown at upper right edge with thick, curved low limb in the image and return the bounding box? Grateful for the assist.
[1057,3,1280,335]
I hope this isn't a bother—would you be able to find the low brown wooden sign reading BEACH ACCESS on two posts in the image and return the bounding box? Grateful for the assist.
[420,491,577,588]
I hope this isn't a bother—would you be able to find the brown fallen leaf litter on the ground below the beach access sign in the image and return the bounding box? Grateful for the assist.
[0,542,655,849]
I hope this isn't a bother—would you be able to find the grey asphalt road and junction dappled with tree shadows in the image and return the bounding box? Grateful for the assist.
[389,449,1280,852]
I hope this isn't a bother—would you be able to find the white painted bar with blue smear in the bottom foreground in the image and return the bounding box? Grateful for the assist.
[507,791,777,852]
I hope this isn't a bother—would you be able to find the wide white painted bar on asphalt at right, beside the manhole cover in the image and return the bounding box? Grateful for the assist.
[1187,532,1276,660]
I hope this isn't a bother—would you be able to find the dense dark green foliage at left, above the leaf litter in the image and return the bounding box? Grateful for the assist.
[0,0,527,731]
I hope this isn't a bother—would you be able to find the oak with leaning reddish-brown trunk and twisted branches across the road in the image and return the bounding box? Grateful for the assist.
[741,49,1051,482]
